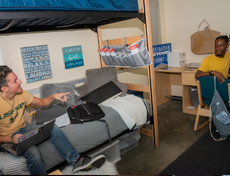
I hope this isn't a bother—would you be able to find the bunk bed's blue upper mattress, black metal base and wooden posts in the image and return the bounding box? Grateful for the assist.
[0,0,159,173]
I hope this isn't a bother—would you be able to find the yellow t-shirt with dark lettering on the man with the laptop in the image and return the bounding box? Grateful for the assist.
[0,90,34,136]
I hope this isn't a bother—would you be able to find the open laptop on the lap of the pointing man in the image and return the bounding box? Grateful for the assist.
[1,120,55,156]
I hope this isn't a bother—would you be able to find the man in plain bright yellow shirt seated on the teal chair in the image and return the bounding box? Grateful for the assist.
[195,35,230,82]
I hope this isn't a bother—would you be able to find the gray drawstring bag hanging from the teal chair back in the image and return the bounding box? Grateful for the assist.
[209,77,230,141]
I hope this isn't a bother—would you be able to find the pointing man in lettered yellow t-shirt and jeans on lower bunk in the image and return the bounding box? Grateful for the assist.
[0,66,105,175]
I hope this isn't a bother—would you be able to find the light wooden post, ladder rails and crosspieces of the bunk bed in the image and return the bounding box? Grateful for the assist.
[97,0,159,147]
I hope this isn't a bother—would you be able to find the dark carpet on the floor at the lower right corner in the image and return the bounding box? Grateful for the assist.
[159,131,230,175]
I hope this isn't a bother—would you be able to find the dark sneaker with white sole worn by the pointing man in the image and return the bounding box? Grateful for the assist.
[73,155,106,173]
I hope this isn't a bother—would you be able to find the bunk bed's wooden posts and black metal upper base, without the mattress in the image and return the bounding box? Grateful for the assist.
[0,0,159,147]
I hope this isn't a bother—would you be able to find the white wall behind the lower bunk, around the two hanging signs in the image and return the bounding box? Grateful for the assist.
[0,29,100,90]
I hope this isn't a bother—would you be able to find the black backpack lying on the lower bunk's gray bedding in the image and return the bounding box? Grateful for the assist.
[67,102,111,144]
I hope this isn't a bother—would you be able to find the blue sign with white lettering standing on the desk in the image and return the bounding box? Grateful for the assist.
[153,43,172,68]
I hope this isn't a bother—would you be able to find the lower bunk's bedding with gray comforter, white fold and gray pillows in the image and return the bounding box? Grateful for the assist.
[0,68,149,175]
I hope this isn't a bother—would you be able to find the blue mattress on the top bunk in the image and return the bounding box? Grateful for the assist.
[0,0,138,12]
